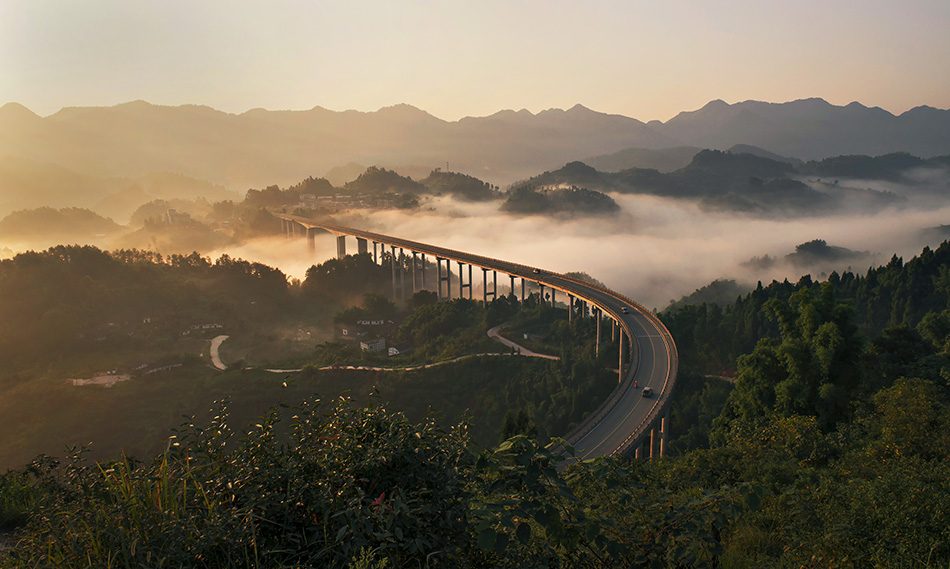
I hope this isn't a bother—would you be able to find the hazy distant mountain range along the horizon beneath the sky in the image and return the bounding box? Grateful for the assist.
[0,99,950,189]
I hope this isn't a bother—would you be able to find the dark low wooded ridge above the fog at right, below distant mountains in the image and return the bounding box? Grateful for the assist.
[519,147,950,217]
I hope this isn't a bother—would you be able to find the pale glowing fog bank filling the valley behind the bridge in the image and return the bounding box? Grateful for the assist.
[211,195,950,309]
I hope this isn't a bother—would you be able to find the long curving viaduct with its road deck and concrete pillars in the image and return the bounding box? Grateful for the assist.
[277,214,678,459]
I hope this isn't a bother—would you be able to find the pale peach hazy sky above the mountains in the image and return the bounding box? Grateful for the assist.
[0,0,950,120]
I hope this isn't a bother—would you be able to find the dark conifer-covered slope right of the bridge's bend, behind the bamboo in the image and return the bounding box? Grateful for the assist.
[661,241,950,373]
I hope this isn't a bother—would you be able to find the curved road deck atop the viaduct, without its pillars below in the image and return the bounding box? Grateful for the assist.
[279,215,678,459]
